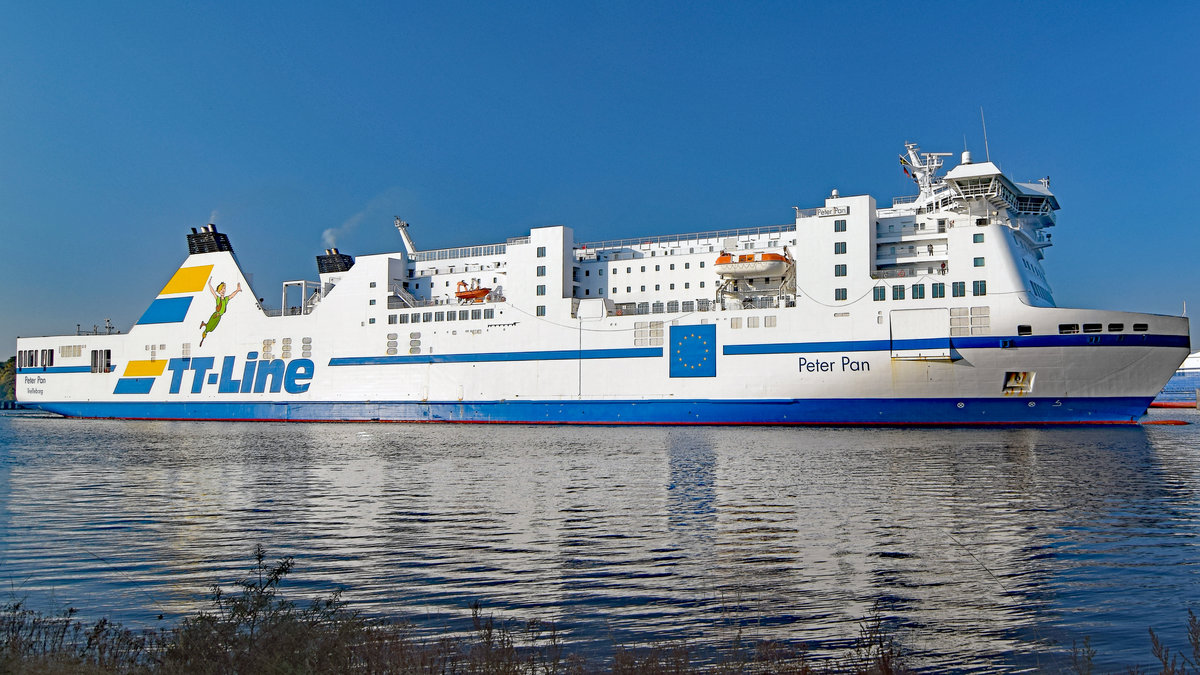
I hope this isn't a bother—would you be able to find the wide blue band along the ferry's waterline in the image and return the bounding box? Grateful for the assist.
[25,396,1151,425]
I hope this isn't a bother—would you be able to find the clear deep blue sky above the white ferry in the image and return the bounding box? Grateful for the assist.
[0,0,1200,356]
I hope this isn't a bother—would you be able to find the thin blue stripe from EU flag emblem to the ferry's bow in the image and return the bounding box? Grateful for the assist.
[722,333,1192,356]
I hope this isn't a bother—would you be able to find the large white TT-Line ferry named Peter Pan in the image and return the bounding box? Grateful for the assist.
[17,144,1190,425]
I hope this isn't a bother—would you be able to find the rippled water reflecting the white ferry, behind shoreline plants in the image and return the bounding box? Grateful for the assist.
[0,411,1200,670]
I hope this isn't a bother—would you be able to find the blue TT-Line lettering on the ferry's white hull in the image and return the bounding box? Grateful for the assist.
[167,352,317,394]
